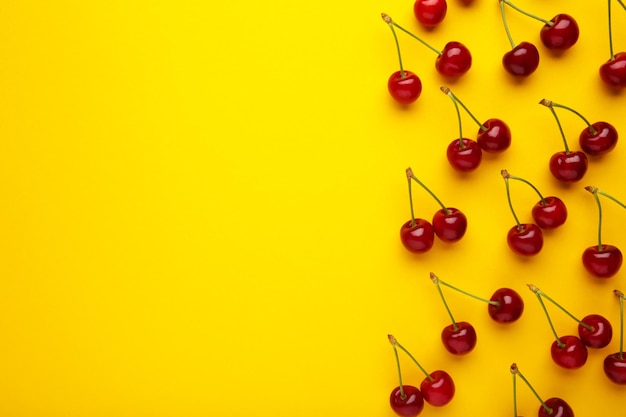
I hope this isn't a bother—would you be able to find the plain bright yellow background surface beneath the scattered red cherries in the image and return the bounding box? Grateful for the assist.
[0,0,626,417]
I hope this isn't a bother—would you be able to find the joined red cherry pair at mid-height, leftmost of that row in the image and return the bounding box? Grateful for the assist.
[400,168,467,253]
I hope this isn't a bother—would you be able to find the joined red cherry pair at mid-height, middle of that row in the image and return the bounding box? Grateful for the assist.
[500,169,567,256]
